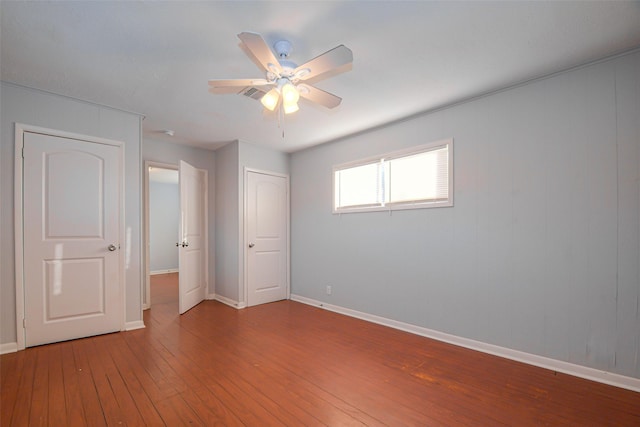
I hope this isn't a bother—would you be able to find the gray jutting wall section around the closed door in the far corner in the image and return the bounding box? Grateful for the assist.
[216,141,289,304]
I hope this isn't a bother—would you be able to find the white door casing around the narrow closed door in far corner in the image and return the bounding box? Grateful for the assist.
[240,167,291,307]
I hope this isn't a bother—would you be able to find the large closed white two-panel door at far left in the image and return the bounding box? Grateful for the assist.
[23,132,123,346]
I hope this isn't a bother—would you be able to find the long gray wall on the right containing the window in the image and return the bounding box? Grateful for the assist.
[291,52,640,378]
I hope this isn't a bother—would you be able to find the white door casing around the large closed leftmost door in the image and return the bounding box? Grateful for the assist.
[14,123,129,351]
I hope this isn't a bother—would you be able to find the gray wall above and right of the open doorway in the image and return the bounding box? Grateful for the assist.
[142,138,216,293]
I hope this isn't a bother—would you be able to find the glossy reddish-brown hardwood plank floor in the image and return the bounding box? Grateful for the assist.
[0,275,640,426]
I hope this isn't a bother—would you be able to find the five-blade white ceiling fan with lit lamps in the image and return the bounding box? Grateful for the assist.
[209,32,353,114]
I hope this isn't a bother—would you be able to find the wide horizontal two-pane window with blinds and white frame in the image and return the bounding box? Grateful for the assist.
[333,139,453,213]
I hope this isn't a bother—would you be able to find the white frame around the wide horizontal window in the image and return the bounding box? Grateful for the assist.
[331,138,454,214]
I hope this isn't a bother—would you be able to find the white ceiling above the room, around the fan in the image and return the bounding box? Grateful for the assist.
[0,1,640,152]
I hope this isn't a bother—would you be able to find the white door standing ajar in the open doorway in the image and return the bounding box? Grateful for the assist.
[178,160,207,314]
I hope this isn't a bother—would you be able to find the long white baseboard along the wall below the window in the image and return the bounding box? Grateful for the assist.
[291,294,640,392]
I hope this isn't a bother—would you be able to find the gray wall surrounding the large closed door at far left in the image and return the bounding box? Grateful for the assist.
[0,82,142,344]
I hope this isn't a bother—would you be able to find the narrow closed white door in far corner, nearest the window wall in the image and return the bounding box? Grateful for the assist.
[246,171,288,306]
